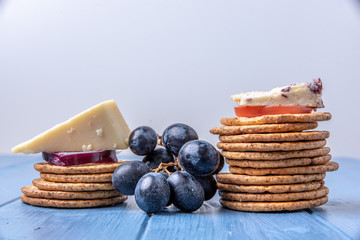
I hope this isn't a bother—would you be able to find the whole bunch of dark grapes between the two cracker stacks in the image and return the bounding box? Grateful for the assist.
[112,123,224,213]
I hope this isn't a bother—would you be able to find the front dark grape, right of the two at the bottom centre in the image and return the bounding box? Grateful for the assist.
[168,171,204,212]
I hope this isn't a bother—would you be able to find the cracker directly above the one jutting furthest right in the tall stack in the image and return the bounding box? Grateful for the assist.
[226,154,331,168]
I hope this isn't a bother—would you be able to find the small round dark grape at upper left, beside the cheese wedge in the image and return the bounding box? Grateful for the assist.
[129,126,157,156]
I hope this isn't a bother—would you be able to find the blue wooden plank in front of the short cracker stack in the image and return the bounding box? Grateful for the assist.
[0,198,147,239]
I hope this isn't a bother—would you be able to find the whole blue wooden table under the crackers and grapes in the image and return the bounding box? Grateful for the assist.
[0,155,360,240]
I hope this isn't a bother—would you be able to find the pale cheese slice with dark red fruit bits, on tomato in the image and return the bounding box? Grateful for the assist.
[231,79,324,108]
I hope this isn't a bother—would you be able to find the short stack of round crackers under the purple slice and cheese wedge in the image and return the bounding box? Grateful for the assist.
[21,161,127,208]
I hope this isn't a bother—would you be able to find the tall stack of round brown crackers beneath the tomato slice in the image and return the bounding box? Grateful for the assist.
[210,113,339,212]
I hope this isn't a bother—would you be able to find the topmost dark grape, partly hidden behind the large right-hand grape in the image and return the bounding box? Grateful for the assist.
[162,123,199,156]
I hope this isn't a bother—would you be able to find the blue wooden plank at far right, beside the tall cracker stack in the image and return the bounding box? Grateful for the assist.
[313,158,360,239]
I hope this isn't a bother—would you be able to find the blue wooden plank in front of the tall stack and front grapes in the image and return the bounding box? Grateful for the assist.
[142,196,348,239]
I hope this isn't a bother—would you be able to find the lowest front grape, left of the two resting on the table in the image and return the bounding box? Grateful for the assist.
[135,173,170,213]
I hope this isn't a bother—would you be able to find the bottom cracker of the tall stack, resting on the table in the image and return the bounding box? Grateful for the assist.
[220,196,328,212]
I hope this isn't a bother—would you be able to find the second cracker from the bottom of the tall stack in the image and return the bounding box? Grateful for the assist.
[219,186,329,202]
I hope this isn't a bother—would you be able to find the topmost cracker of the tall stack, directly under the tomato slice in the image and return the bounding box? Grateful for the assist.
[220,112,331,126]
